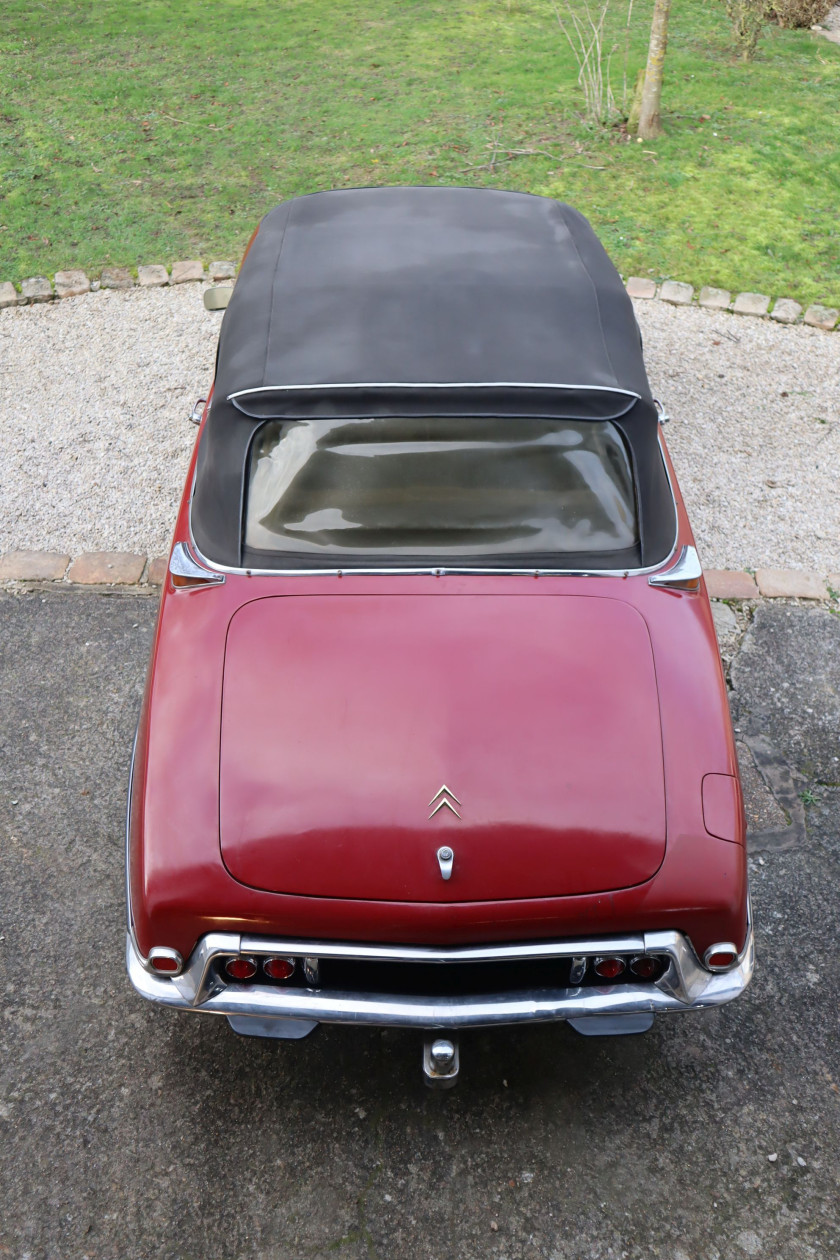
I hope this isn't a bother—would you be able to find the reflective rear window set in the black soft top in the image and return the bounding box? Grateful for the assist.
[244,416,639,559]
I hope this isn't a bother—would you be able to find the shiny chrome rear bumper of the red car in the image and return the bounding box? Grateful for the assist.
[126,922,754,1029]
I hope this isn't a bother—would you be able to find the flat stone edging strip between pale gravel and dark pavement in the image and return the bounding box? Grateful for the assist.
[0,551,840,602]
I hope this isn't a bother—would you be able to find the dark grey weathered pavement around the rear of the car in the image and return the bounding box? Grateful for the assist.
[0,588,840,1260]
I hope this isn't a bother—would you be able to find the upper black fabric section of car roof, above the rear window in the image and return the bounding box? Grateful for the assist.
[217,188,650,416]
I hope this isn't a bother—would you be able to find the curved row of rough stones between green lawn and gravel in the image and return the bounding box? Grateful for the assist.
[0,258,840,333]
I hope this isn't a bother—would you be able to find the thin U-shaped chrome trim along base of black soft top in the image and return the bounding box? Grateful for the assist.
[188,437,680,577]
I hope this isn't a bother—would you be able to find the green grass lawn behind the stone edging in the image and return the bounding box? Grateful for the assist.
[0,0,840,305]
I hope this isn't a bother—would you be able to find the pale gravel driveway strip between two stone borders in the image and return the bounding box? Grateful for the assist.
[0,285,840,573]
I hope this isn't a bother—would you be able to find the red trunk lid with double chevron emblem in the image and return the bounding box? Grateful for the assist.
[220,592,665,902]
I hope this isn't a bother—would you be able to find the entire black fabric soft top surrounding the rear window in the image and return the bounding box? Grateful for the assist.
[191,188,674,568]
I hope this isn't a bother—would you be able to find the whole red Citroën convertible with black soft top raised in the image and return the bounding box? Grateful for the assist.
[127,188,753,1086]
